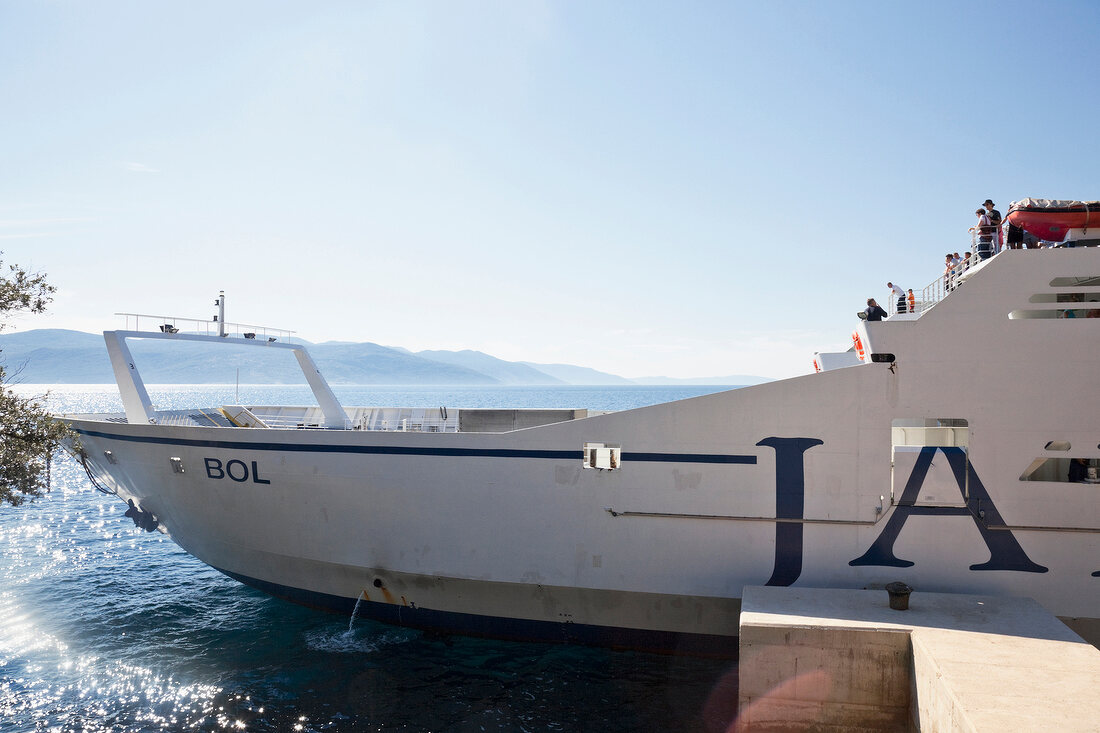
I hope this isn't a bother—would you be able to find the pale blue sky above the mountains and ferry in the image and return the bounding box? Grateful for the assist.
[0,0,1100,376]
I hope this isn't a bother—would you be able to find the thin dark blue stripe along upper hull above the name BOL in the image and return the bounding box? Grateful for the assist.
[76,428,756,464]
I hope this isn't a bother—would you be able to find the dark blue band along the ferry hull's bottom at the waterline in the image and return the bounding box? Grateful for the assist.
[216,568,737,659]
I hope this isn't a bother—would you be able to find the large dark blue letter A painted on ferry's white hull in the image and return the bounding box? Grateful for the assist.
[848,446,1047,572]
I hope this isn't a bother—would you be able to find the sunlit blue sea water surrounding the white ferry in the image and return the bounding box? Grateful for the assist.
[0,385,737,733]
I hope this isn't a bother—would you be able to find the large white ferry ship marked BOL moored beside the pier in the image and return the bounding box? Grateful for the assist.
[64,199,1100,653]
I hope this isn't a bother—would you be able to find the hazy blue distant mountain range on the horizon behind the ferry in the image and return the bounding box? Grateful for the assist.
[0,329,771,385]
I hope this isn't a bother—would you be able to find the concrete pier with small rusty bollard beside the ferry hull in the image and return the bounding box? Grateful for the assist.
[738,587,1100,732]
